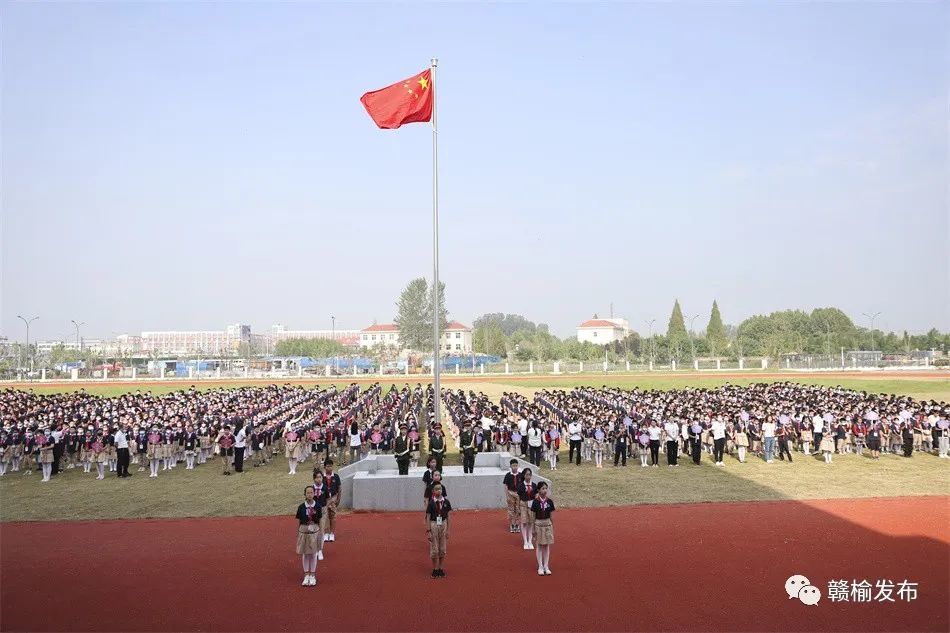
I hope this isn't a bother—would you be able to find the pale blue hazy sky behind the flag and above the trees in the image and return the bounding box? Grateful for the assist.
[0,2,950,338]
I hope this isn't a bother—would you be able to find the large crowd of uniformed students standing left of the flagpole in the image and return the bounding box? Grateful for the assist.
[0,384,444,482]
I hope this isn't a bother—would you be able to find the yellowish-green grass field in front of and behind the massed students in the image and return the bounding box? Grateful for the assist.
[0,374,950,521]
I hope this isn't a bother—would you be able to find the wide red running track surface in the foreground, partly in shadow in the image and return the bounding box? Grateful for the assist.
[0,497,950,631]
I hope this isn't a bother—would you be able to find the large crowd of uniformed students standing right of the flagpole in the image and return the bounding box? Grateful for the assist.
[494,382,950,470]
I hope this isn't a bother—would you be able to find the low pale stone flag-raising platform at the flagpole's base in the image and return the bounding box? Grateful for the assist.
[337,453,553,511]
